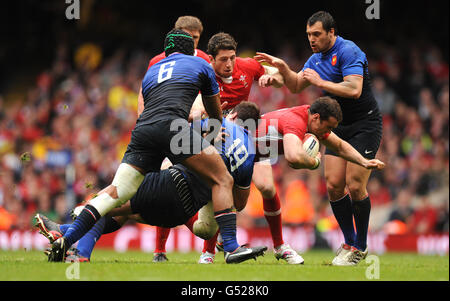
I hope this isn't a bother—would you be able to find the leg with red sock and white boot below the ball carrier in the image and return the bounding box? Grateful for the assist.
[252,161,304,264]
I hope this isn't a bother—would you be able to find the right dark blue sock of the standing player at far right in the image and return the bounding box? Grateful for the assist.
[352,196,371,251]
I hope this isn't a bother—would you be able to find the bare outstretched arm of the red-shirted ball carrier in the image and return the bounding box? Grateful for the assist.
[321,132,385,169]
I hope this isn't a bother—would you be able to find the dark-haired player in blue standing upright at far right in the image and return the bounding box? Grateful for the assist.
[255,11,382,265]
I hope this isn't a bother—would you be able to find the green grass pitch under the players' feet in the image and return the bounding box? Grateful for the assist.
[0,250,449,281]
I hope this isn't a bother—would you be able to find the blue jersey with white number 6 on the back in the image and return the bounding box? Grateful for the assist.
[136,53,219,126]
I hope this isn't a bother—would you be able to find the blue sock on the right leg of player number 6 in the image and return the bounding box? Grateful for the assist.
[214,208,240,253]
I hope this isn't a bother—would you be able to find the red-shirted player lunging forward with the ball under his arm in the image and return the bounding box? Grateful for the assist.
[193,97,384,264]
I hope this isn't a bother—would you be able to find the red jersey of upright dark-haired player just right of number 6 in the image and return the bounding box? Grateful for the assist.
[216,57,265,110]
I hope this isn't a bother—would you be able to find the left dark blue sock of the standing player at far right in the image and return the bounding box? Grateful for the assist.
[330,194,356,246]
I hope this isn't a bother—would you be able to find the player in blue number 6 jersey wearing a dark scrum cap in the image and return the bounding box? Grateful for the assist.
[49,29,264,261]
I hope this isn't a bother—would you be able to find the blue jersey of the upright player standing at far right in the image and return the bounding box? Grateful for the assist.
[302,36,379,125]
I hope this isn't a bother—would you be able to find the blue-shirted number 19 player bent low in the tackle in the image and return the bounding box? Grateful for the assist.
[36,102,267,263]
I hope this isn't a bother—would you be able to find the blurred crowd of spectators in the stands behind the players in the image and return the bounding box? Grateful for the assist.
[0,0,449,234]
